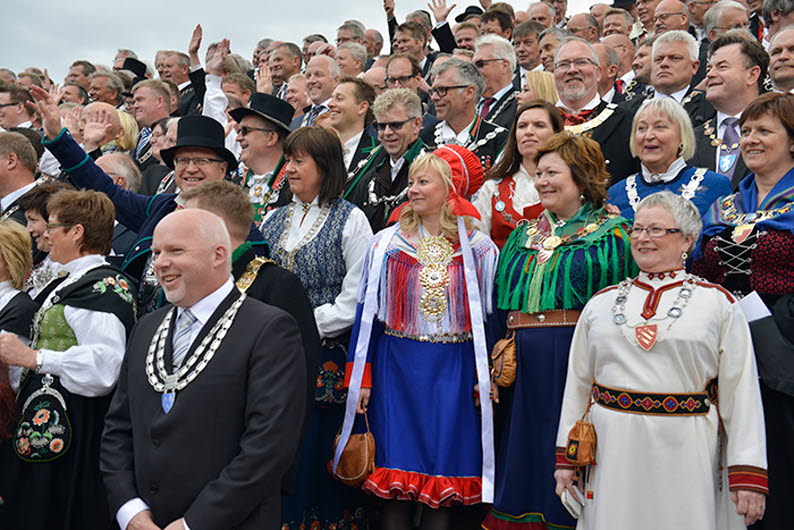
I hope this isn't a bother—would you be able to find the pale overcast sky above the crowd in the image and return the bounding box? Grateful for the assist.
[0,0,597,82]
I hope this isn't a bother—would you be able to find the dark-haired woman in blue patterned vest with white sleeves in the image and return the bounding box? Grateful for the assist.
[261,127,372,530]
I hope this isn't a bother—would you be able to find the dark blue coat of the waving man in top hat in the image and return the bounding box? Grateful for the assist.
[43,129,264,279]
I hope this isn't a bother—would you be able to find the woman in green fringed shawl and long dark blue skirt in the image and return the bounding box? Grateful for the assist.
[483,133,636,530]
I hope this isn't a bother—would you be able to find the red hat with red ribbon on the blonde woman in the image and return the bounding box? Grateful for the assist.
[389,145,485,223]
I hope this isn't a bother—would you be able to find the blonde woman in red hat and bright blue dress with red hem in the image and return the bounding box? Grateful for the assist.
[337,146,497,530]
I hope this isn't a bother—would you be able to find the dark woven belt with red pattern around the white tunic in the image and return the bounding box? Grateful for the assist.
[593,379,717,416]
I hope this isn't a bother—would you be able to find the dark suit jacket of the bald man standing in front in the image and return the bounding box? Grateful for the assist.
[100,289,306,530]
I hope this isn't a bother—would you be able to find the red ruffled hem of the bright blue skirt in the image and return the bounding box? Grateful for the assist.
[361,467,482,508]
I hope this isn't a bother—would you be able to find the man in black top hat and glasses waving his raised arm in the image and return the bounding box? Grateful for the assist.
[32,87,262,312]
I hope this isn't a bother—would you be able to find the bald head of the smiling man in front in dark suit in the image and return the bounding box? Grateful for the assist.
[152,209,232,307]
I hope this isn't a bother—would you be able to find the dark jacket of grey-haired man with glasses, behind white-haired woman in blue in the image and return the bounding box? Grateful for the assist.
[580,101,640,185]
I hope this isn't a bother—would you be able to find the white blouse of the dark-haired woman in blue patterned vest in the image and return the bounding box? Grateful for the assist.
[262,196,372,337]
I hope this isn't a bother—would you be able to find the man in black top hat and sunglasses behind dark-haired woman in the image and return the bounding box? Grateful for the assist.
[229,92,295,226]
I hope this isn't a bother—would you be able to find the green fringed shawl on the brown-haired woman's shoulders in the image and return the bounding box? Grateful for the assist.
[496,205,638,313]
